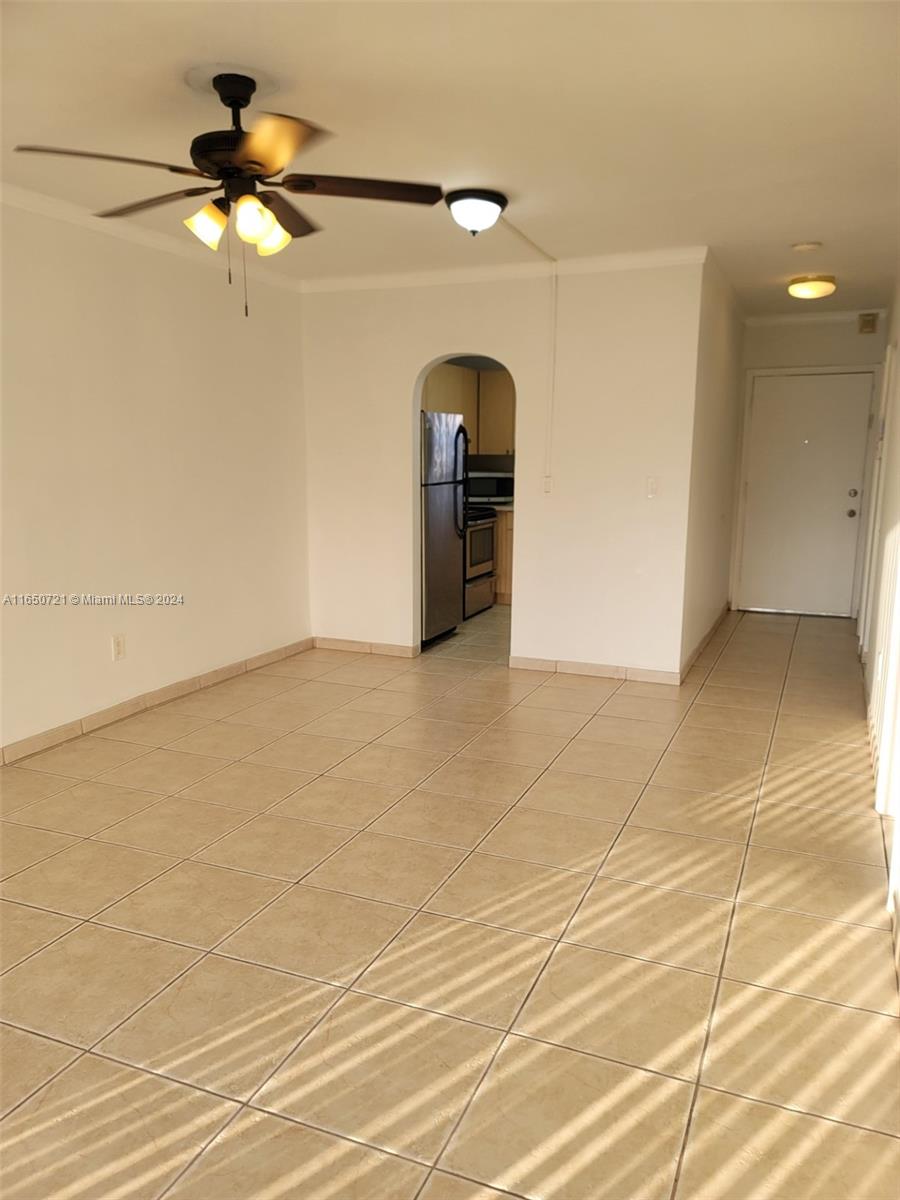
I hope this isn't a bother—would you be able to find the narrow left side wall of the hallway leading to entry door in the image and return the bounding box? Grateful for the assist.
[682,258,743,665]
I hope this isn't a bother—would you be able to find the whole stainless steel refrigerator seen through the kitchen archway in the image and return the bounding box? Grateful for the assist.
[421,413,468,642]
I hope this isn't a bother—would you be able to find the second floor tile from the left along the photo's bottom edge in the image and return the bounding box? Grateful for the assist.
[167,1109,425,1200]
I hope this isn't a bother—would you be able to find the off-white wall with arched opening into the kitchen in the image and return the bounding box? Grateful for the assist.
[302,259,702,671]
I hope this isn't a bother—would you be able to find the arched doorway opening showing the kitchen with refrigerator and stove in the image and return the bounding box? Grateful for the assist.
[414,354,516,665]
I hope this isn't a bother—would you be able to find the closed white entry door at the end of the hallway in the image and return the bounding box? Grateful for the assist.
[737,372,872,617]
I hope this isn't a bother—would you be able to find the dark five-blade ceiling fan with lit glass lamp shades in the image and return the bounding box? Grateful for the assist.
[16,74,444,256]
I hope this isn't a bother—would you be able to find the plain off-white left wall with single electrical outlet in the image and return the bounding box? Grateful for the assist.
[1,208,310,744]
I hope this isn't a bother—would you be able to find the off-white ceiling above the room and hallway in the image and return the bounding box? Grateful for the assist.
[2,0,900,313]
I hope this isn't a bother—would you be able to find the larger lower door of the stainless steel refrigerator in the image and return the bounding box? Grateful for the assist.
[421,484,463,641]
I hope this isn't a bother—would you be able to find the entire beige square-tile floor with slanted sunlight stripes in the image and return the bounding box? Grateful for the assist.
[0,608,900,1200]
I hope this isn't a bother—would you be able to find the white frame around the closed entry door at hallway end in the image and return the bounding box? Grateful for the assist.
[728,362,882,618]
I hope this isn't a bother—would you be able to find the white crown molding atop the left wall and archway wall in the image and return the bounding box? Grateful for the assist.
[0,184,708,302]
